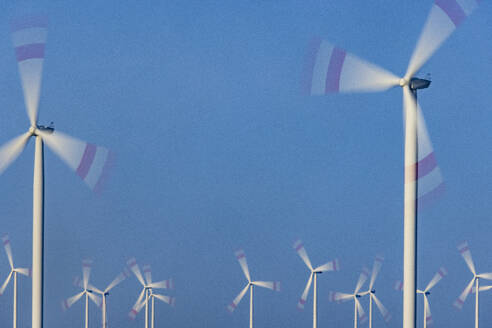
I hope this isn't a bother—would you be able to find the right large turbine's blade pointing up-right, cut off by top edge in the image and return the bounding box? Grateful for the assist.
[405,0,479,79]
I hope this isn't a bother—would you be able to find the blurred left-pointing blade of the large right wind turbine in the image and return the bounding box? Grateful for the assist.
[304,39,400,95]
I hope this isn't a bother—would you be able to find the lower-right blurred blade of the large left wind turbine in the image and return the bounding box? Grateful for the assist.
[37,130,114,192]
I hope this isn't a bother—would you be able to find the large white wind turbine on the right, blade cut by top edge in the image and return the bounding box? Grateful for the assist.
[305,0,478,328]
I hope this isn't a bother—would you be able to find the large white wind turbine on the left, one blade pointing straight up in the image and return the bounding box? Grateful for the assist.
[0,17,112,328]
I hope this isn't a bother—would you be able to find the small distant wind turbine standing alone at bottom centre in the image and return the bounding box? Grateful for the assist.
[227,249,280,328]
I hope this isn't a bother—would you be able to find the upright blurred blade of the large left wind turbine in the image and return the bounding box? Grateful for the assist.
[12,17,48,126]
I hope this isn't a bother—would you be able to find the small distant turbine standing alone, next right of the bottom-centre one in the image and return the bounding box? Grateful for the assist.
[293,239,340,328]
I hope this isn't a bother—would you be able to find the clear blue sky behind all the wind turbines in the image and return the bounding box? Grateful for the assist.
[0,0,492,328]
